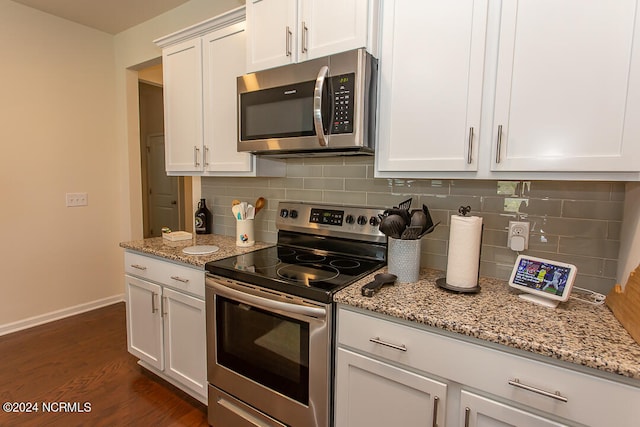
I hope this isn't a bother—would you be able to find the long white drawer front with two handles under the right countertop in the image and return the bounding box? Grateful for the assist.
[338,308,640,426]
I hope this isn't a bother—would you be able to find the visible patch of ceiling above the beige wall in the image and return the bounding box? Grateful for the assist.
[13,0,189,34]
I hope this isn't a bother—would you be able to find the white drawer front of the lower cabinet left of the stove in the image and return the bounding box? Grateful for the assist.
[124,252,204,299]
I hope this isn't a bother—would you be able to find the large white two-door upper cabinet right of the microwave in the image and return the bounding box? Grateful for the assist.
[375,0,640,181]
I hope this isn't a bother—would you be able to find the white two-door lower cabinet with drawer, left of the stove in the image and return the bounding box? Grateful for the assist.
[125,252,207,403]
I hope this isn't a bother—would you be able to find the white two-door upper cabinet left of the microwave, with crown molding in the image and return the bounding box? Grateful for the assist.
[156,8,285,176]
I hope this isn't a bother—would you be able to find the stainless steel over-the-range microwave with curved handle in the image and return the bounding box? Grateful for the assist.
[238,49,378,157]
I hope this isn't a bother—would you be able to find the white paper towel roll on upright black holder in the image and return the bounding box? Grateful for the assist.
[446,215,482,288]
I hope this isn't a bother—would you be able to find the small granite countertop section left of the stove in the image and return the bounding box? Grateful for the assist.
[120,234,274,269]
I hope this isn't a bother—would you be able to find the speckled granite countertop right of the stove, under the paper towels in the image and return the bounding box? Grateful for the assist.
[334,268,640,386]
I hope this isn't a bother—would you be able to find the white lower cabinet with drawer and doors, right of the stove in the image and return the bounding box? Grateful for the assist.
[335,305,640,427]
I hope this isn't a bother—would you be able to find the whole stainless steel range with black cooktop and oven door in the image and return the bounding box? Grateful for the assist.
[206,202,386,427]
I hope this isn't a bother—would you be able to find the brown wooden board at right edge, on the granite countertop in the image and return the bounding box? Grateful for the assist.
[606,266,640,344]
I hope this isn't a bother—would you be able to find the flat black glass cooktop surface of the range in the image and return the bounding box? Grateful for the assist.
[205,245,385,302]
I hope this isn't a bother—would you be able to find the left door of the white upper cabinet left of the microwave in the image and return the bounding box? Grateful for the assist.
[162,39,203,172]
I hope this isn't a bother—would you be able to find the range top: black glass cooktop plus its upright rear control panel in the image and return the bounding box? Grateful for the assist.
[205,202,387,302]
